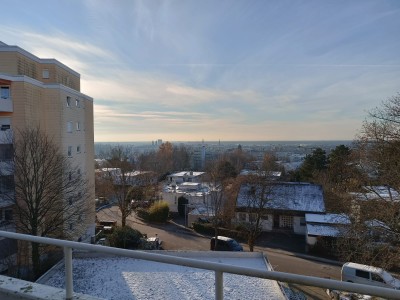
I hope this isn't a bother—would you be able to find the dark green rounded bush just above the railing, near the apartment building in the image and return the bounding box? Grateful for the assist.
[108,226,143,249]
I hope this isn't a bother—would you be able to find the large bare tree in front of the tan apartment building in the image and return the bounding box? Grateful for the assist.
[6,127,90,277]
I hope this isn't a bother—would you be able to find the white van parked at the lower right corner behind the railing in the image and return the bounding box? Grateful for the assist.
[342,262,400,289]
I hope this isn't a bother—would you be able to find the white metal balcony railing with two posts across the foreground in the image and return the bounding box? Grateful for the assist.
[0,231,400,299]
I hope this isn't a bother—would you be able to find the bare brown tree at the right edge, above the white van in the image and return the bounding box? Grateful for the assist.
[332,94,400,267]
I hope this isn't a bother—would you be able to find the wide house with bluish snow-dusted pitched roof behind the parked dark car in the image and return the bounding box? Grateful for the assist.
[235,182,325,235]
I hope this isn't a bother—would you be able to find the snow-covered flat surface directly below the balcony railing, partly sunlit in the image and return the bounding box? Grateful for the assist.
[46,256,283,300]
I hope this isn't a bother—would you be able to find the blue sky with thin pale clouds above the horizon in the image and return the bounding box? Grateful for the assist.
[0,0,400,142]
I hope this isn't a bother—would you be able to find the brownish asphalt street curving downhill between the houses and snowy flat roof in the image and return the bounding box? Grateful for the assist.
[97,206,340,299]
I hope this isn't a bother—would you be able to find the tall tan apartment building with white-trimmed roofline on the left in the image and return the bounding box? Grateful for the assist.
[0,41,95,271]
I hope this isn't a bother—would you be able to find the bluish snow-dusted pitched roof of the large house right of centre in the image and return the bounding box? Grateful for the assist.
[237,182,325,213]
